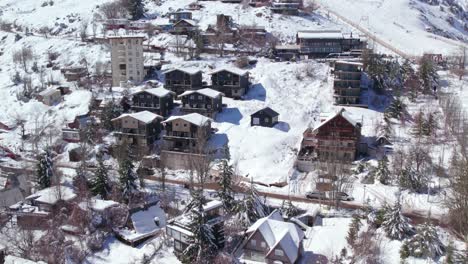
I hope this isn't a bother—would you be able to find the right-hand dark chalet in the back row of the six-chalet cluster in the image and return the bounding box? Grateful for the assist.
[210,68,249,99]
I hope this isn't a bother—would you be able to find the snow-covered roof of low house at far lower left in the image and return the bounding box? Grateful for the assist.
[26,185,76,205]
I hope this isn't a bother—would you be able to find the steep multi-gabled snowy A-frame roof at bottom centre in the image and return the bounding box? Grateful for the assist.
[247,210,304,263]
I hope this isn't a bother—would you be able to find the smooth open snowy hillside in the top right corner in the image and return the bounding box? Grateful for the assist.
[319,0,468,56]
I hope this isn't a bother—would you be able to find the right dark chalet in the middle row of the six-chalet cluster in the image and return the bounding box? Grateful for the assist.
[178,88,223,118]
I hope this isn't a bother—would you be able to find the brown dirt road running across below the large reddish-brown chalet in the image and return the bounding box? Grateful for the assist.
[145,176,447,227]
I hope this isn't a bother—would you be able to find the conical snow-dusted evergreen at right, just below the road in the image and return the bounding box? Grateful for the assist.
[382,198,413,240]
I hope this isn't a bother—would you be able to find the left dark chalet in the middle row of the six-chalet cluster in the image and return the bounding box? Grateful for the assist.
[131,88,175,117]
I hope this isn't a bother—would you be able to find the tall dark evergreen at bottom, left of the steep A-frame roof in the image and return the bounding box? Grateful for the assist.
[181,190,218,263]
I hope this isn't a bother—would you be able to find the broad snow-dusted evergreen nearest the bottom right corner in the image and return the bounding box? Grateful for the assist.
[405,221,445,258]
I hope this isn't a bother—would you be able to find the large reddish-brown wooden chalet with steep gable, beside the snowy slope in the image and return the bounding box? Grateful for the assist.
[298,108,362,163]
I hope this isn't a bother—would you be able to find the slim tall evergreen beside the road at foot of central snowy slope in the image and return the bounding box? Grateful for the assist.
[218,160,236,212]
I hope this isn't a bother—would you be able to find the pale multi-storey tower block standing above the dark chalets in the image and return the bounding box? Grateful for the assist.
[109,36,145,87]
